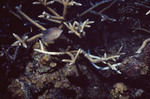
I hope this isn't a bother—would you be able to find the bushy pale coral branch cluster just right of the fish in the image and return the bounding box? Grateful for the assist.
[64,19,94,37]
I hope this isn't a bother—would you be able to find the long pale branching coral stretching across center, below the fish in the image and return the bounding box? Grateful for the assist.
[34,41,125,74]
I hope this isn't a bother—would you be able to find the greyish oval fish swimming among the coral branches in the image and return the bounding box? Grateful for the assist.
[42,27,63,42]
